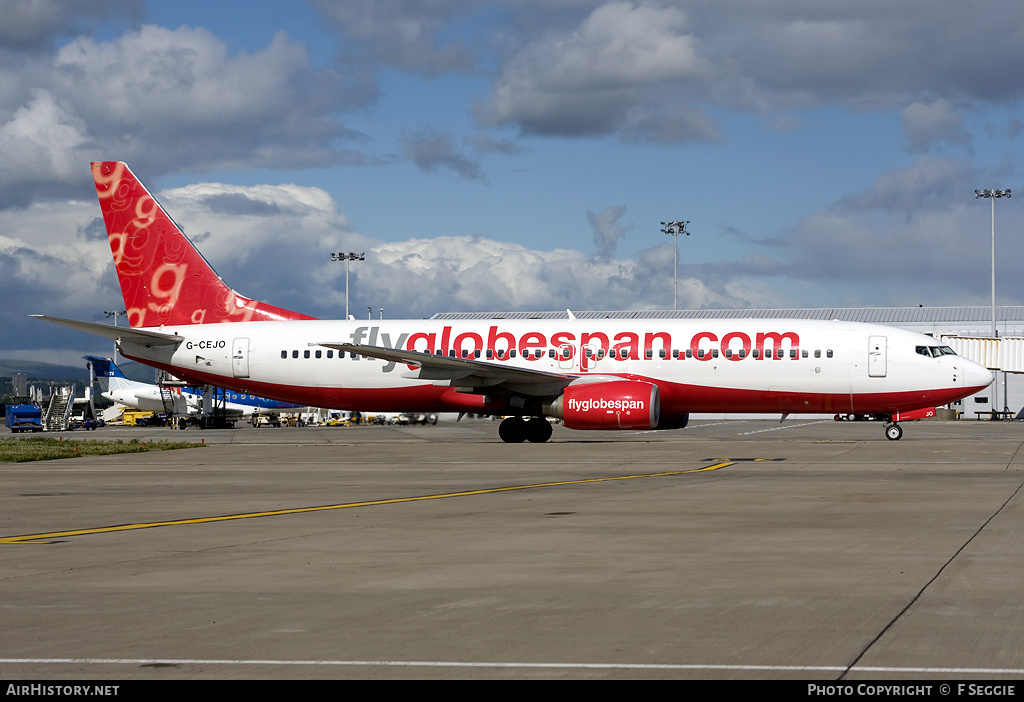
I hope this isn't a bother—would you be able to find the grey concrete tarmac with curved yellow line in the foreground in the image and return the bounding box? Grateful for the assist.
[0,416,1024,679]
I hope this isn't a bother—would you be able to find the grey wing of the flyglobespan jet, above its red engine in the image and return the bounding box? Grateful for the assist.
[319,343,579,396]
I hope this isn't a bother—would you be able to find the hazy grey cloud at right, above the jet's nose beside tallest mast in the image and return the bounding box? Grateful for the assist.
[766,157,1024,305]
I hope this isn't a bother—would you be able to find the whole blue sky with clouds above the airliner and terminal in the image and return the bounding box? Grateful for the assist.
[0,0,1024,363]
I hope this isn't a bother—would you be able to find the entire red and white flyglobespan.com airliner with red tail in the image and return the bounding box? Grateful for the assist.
[34,162,993,443]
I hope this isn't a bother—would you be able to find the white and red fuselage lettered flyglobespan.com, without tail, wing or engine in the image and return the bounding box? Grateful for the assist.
[121,319,992,413]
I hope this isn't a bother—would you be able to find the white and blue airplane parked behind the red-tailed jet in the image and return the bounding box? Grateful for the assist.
[88,356,307,418]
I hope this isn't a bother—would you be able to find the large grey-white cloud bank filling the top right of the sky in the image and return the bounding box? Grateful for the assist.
[468,0,1024,144]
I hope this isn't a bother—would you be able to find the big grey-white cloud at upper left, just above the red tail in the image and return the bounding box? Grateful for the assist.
[0,26,360,207]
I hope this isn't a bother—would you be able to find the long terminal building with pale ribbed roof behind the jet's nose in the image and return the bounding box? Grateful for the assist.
[431,306,1024,420]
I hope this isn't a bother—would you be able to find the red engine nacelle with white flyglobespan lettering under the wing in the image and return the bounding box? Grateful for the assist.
[545,381,662,429]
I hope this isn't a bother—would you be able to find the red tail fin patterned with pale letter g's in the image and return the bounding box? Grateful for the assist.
[92,161,315,326]
